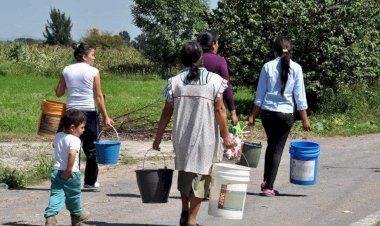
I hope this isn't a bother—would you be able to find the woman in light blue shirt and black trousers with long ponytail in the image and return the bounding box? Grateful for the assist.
[248,37,310,196]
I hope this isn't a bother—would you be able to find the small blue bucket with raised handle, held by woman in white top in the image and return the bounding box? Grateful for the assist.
[94,126,120,164]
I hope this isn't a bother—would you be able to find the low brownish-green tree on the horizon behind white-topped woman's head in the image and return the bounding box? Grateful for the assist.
[83,28,125,48]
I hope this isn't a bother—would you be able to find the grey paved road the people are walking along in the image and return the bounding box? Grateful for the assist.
[0,134,380,226]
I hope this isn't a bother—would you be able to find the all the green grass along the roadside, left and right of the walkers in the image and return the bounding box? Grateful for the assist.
[0,73,380,141]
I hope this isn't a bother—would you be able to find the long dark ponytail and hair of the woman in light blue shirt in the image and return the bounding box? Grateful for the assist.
[273,37,292,96]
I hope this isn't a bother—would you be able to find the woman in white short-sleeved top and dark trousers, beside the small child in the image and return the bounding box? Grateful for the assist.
[55,43,113,189]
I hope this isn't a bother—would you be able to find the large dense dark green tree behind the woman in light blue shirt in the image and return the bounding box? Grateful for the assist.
[208,0,380,111]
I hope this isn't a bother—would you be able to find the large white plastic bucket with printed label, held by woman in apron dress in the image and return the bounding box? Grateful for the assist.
[208,163,251,220]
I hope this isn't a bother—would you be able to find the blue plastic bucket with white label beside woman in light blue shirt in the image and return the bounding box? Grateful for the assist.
[289,141,319,185]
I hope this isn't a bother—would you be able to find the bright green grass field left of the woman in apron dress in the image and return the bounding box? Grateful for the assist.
[0,76,165,140]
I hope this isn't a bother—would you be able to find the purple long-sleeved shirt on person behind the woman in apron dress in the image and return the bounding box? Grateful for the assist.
[203,52,235,111]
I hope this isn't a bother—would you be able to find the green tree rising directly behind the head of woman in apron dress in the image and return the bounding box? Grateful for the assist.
[132,0,209,77]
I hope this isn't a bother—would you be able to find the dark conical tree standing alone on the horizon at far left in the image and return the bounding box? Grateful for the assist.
[43,8,73,45]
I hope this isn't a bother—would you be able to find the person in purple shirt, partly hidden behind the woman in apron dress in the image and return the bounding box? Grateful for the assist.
[197,31,238,125]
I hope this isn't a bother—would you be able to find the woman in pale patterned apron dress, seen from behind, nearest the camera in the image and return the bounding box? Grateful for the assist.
[153,42,233,226]
